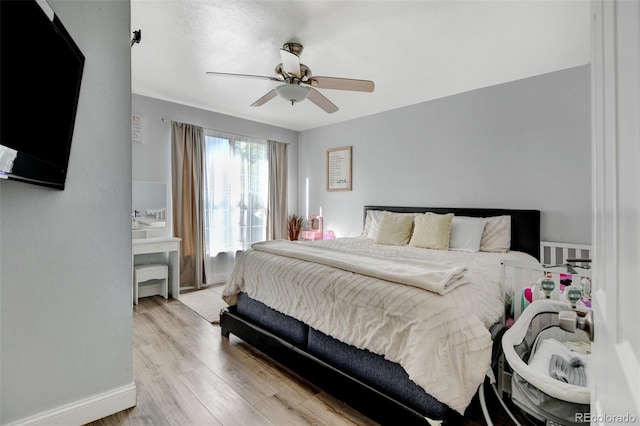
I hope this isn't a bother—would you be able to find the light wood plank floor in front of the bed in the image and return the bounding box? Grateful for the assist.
[90,296,524,426]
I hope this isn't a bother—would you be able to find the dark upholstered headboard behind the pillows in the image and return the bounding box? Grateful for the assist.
[362,206,540,259]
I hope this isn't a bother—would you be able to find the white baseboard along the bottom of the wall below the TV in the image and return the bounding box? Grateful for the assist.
[7,382,137,426]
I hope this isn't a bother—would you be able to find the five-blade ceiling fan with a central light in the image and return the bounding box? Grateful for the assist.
[207,42,374,113]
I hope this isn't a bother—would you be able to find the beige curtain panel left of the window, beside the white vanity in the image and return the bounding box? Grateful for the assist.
[171,121,206,288]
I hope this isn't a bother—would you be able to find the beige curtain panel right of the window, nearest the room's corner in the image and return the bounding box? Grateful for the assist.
[266,141,288,240]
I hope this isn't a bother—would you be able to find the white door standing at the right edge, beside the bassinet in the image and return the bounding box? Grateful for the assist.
[585,0,640,425]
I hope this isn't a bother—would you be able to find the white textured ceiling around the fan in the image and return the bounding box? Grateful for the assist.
[131,0,590,131]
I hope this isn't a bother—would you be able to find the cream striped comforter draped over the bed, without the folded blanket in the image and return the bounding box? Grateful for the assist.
[223,237,538,413]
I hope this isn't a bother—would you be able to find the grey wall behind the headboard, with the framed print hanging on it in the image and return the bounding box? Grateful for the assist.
[299,65,591,244]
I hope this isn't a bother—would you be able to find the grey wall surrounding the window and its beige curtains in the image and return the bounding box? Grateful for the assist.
[132,95,298,235]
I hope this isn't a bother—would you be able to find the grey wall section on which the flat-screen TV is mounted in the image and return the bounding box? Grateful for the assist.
[0,0,135,424]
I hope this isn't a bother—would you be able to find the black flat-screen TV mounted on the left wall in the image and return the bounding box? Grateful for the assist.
[0,0,85,190]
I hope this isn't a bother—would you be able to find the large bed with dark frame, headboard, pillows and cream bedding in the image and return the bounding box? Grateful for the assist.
[220,206,540,424]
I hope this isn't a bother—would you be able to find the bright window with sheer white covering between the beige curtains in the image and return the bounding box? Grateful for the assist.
[203,130,269,257]
